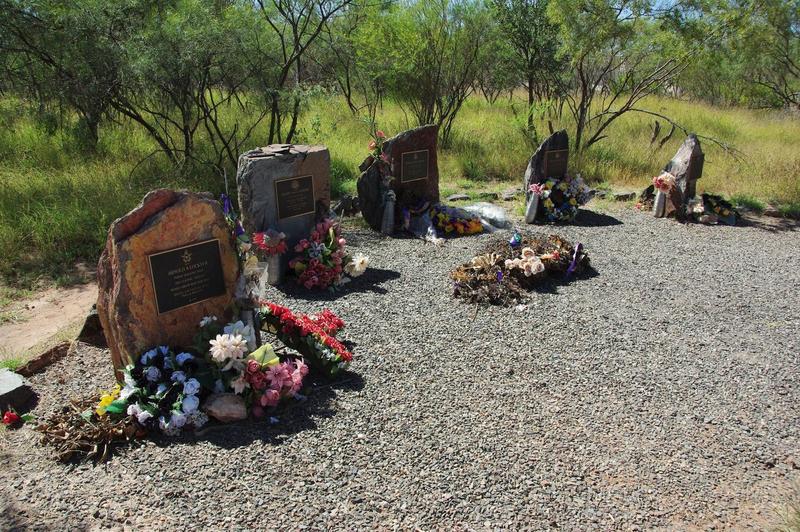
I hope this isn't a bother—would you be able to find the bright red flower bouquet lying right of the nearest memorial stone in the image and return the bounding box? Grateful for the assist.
[259,301,353,377]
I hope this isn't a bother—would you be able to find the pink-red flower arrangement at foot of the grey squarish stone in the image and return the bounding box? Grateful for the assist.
[289,220,348,290]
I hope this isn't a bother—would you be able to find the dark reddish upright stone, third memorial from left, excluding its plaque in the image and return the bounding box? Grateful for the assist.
[357,125,439,231]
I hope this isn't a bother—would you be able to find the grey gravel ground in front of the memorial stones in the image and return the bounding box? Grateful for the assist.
[0,206,800,530]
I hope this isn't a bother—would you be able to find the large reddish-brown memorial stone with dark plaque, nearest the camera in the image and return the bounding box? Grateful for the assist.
[97,189,239,377]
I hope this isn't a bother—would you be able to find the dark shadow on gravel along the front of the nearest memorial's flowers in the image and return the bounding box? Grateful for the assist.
[178,371,364,449]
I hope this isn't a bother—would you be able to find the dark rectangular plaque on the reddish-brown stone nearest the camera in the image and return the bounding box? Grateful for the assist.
[147,239,225,314]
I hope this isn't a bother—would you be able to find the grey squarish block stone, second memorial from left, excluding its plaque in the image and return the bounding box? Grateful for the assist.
[236,144,331,255]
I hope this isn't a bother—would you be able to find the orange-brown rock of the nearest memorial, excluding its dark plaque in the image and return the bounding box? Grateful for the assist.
[97,189,239,376]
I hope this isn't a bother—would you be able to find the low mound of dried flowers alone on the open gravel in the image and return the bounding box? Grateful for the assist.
[450,233,589,305]
